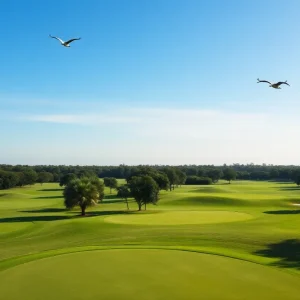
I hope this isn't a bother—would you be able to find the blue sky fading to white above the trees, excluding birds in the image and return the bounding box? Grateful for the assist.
[0,0,300,165]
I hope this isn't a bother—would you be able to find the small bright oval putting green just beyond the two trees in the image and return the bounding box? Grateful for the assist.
[105,211,253,226]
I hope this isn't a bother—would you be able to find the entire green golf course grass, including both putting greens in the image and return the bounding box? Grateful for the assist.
[0,181,300,300]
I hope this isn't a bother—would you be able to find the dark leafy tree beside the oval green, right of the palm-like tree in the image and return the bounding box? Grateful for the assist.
[128,175,159,211]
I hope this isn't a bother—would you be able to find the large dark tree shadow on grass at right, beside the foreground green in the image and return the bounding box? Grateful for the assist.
[255,239,300,269]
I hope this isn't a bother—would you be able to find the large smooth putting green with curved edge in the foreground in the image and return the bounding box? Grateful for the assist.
[0,249,300,300]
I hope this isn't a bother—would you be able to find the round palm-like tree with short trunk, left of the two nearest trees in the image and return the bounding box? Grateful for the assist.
[63,177,99,216]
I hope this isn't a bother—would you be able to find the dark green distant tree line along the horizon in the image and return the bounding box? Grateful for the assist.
[0,164,300,189]
